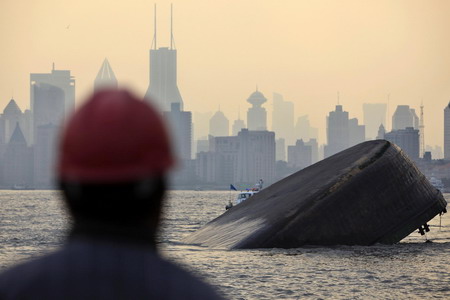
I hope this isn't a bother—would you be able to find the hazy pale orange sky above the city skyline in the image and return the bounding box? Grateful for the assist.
[0,0,450,145]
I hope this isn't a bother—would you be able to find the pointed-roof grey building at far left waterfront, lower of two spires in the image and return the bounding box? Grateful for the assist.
[1,123,33,188]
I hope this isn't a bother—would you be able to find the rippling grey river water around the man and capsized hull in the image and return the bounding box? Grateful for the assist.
[0,191,450,299]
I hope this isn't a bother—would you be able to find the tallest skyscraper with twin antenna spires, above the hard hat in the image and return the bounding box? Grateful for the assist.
[145,4,183,111]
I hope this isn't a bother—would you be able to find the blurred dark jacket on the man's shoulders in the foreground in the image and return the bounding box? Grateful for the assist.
[0,227,224,300]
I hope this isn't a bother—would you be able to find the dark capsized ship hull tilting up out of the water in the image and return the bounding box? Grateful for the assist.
[184,140,447,249]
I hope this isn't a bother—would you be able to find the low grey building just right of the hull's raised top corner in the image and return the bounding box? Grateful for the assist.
[384,127,419,160]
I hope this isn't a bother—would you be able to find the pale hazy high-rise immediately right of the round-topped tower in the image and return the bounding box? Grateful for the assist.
[272,93,295,145]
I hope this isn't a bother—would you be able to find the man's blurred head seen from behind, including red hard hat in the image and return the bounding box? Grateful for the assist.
[58,90,174,224]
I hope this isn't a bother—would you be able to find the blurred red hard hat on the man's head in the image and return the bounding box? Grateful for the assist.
[58,89,174,183]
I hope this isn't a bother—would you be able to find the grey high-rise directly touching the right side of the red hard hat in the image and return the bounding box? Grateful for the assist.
[164,103,192,160]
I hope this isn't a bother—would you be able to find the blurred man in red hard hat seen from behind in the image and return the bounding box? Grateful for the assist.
[0,90,220,299]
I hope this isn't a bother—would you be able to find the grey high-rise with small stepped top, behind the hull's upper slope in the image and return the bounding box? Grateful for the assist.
[324,105,350,158]
